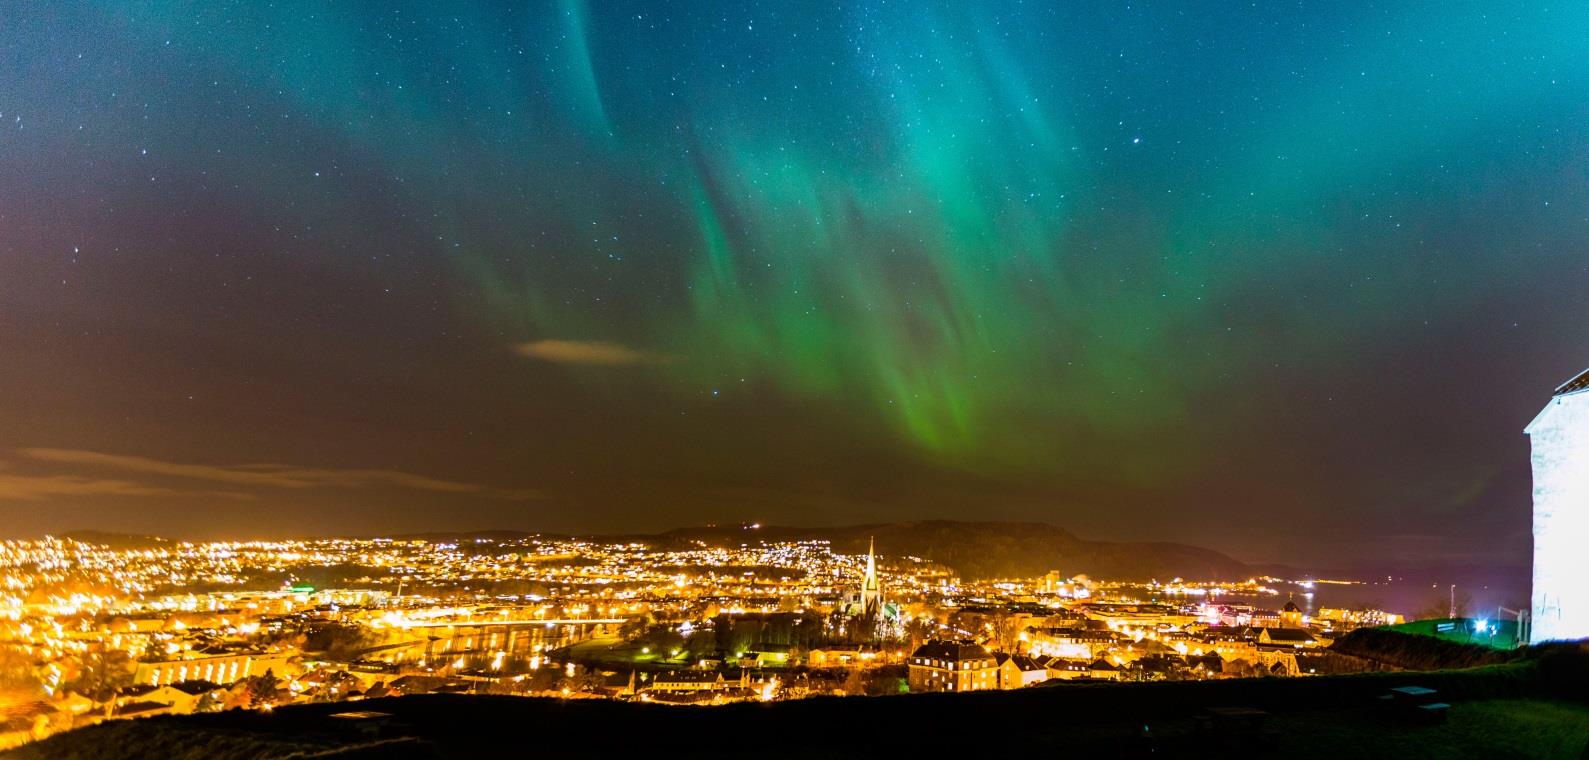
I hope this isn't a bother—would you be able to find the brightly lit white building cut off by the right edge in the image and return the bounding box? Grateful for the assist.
[1524,370,1589,644]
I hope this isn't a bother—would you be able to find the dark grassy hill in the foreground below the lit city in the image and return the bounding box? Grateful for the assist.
[15,649,1589,760]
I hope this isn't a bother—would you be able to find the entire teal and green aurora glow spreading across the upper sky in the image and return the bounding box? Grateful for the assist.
[19,0,1589,499]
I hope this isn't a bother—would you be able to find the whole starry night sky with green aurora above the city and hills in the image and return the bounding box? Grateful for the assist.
[0,0,1589,568]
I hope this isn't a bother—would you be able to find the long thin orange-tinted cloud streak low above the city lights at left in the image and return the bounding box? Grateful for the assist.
[19,448,540,501]
